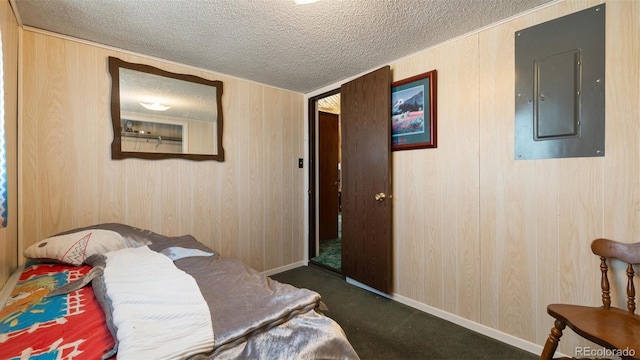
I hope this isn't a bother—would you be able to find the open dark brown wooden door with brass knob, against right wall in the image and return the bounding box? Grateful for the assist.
[340,66,392,293]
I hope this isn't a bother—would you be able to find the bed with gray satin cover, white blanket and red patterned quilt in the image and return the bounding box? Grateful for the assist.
[0,223,358,360]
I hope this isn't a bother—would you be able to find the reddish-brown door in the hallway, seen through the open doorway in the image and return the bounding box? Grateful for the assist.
[318,112,340,240]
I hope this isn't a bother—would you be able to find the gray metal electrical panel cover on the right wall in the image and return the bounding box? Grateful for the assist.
[515,4,605,159]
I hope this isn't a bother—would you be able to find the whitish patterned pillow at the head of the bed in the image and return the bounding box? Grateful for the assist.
[24,229,128,266]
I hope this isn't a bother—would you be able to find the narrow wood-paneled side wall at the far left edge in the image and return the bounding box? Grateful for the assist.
[0,1,18,286]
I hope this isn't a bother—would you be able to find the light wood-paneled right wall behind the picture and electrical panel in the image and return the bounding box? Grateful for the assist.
[392,0,640,356]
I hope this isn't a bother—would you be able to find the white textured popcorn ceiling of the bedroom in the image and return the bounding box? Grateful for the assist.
[11,0,557,93]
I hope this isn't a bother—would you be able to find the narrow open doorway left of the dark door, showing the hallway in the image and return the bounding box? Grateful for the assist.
[309,89,342,273]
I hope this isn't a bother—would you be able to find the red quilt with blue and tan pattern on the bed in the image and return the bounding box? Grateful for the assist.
[0,260,114,360]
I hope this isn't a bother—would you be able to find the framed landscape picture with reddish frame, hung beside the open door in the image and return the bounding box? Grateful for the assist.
[391,70,437,151]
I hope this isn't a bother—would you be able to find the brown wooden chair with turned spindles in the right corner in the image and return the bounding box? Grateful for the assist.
[540,239,640,360]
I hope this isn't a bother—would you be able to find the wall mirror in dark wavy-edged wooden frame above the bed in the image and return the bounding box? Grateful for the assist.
[109,56,224,161]
